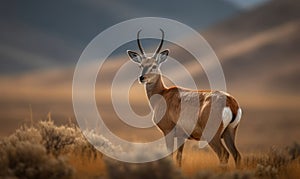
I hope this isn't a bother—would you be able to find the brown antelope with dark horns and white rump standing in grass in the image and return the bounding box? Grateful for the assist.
[127,29,242,167]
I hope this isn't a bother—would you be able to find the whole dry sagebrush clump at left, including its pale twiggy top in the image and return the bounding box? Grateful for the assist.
[0,120,108,178]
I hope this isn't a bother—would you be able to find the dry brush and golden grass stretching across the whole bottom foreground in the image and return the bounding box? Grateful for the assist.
[0,120,300,178]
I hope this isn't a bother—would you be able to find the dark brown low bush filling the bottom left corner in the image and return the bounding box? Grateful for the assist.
[0,129,73,178]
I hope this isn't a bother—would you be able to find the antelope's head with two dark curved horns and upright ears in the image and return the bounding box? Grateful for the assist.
[127,29,169,83]
